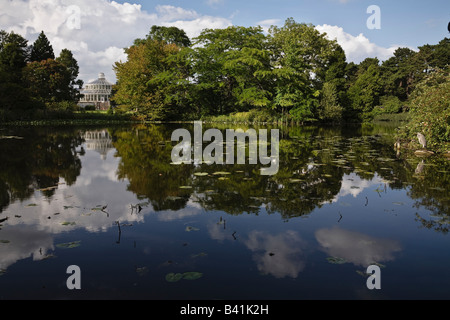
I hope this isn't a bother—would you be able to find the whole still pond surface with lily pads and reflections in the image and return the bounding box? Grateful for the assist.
[0,124,450,300]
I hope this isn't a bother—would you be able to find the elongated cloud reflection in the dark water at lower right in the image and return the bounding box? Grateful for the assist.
[315,227,402,267]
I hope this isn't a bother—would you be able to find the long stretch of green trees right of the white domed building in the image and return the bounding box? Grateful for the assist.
[113,19,450,123]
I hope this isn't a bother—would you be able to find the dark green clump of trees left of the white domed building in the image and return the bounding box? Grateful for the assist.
[0,30,83,121]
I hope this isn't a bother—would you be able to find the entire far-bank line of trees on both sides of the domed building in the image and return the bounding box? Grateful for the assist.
[0,18,450,129]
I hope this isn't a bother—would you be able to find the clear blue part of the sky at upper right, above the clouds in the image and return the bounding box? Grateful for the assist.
[123,0,450,47]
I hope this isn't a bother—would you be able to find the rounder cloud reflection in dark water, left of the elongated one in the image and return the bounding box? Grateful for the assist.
[245,231,306,278]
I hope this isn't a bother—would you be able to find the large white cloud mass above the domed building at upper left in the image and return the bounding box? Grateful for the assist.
[0,0,231,82]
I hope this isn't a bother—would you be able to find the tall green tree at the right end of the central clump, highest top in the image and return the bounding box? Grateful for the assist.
[269,18,345,121]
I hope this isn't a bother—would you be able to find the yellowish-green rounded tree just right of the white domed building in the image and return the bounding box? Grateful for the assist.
[113,34,190,120]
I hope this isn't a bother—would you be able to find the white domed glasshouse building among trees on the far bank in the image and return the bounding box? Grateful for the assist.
[78,73,113,110]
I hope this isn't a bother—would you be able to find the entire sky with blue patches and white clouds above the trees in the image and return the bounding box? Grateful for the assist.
[0,0,450,83]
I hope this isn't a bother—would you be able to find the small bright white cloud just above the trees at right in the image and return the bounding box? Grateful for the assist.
[316,24,398,63]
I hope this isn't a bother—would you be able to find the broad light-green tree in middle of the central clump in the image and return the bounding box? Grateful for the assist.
[193,26,272,114]
